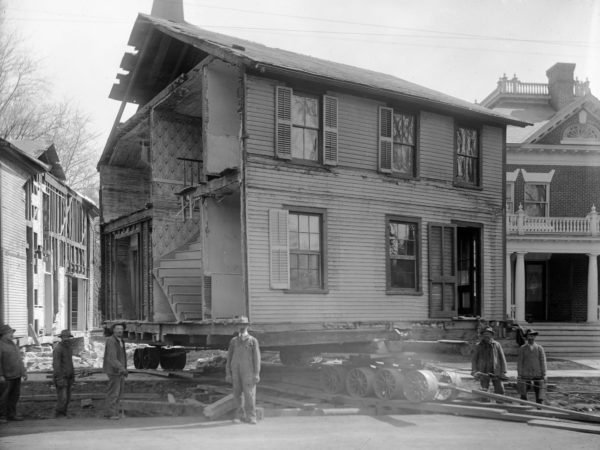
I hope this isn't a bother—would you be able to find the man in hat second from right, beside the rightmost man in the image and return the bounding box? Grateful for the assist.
[471,327,506,395]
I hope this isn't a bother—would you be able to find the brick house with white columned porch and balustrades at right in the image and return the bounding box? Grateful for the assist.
[481,63,600,356]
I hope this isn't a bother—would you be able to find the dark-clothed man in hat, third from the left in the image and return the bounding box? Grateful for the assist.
[102,323,128,420]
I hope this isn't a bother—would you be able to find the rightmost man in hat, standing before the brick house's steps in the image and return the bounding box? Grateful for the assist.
[517,329,546,403]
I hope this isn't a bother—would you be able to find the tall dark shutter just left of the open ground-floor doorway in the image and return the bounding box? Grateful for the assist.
[429,223,458,318]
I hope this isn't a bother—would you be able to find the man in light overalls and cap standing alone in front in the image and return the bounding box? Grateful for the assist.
[225,316,260,425]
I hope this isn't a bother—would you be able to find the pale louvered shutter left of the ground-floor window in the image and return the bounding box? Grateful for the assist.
[269,209,290,289]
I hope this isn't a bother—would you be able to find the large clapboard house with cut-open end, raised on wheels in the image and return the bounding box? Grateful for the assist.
[98,3,525,352]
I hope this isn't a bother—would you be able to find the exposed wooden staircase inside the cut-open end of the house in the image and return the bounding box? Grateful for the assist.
[154,237,205,320]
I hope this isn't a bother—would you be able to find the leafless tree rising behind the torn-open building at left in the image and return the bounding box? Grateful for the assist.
[0,0,98,201]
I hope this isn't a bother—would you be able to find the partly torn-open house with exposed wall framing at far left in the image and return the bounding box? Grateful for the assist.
[0,140,98,336]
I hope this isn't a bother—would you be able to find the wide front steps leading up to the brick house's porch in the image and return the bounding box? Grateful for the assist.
[521,322,600,358]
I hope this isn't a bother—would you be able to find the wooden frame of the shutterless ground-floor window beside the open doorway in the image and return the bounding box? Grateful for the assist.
[384,214,423,295]
